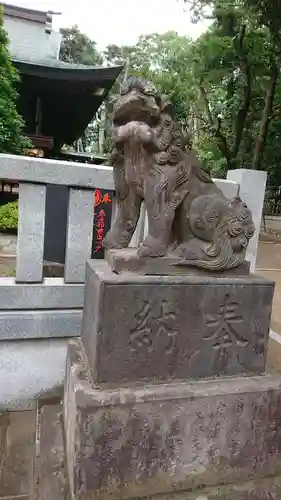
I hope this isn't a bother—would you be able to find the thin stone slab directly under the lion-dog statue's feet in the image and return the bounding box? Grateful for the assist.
[106,248,250,277]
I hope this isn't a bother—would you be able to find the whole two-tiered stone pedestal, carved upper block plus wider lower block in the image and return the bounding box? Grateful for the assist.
[61,261,281,500]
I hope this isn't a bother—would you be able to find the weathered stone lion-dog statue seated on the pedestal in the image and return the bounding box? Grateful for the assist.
[104,78,254,271]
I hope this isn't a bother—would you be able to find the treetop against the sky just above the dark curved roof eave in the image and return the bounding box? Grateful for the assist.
[60,25,103,66]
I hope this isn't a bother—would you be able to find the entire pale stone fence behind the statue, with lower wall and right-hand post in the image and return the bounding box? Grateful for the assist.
[0,155,266,410]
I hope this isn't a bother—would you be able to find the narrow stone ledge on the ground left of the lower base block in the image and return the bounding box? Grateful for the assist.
[31,404,69,500]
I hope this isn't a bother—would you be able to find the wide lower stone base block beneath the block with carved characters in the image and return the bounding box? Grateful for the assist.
[64,340,281,500]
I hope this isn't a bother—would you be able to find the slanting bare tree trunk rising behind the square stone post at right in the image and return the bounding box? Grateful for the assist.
[252,62,279,170]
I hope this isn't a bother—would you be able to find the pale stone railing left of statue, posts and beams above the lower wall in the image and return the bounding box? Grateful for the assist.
[0,155,113,348]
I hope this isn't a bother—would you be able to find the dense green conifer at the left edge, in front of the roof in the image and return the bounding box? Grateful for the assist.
[0,8,30,154]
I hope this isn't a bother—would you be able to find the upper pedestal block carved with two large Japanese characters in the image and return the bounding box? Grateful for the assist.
[82,261,274,384]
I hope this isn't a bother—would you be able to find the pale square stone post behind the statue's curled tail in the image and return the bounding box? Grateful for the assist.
[227,168,267,272]
